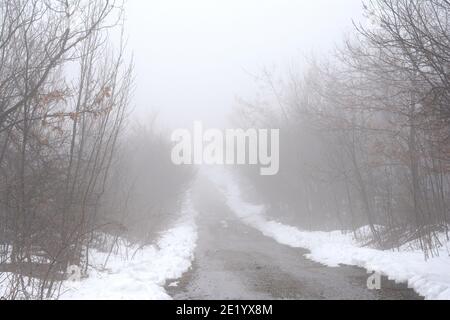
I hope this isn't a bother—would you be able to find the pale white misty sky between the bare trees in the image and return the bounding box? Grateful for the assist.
[121,0,362,127]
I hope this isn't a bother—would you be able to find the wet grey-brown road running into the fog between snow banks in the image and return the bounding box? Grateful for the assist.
[166,175,420,300]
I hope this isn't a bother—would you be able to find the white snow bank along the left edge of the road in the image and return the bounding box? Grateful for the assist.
[60,198,197,300]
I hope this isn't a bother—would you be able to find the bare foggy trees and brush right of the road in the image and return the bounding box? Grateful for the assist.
[235,0,450,257]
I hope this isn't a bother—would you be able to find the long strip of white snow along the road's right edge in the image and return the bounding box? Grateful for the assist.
[206,168,450,300]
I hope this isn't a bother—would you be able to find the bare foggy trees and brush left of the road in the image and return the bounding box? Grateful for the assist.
[0,0,189,298]
